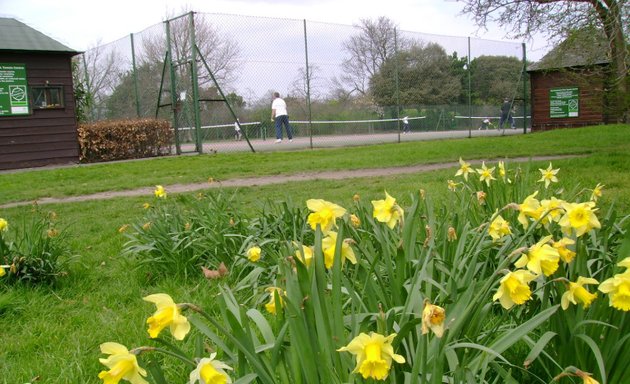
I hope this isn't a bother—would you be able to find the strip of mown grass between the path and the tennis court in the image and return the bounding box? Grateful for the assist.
[0,125,630,204]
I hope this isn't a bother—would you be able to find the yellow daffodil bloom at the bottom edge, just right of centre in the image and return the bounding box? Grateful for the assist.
[337,332,405,380]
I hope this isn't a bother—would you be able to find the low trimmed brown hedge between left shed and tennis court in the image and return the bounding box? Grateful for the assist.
[79,119,173,163]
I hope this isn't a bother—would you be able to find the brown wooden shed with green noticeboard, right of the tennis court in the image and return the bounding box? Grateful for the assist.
[527,31,614,131]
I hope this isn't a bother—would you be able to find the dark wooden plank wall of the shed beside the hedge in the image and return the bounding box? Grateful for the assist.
[0,52,79,170]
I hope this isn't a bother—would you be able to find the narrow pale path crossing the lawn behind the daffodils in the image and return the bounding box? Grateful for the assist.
[0,155,577,208]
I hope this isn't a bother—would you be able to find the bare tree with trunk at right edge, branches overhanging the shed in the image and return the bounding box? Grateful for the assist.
[462,0,630,122]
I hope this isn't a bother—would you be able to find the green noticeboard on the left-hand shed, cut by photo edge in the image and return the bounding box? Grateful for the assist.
[0,63,29,116]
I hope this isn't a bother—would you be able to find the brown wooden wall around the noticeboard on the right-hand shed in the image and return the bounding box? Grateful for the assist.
[529,70,606,131]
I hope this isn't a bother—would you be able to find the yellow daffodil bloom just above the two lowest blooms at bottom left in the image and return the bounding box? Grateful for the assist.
[143,293,190,340]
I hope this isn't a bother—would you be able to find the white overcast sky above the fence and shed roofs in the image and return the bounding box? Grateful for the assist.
[0,0,549,60]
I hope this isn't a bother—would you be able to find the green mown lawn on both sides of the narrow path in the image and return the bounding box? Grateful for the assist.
[0,126,630,383]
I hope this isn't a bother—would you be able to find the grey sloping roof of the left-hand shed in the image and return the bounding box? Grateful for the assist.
[0,17,78,53]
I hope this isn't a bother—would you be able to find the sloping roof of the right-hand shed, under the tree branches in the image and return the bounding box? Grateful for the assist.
[527,30,610,72]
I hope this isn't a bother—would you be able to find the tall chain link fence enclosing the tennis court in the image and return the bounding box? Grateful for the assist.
[77,12,529,153]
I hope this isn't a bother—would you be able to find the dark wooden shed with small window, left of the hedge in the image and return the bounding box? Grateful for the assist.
[0,18,79,170]
